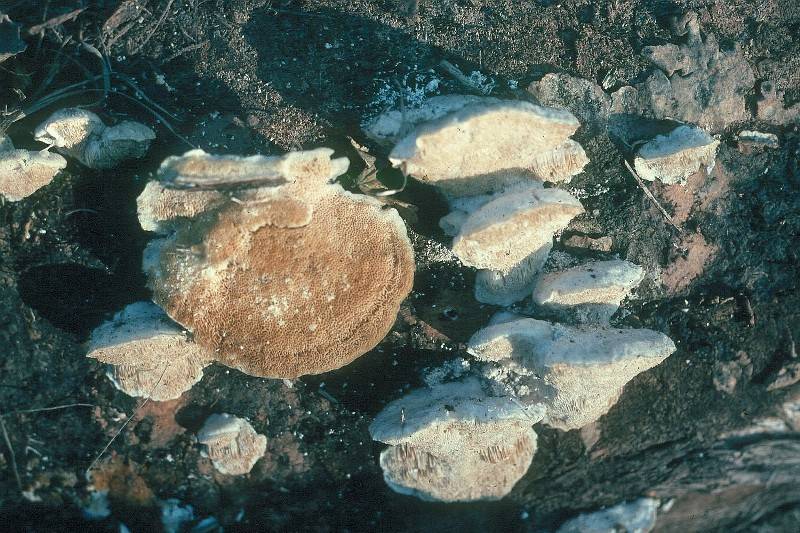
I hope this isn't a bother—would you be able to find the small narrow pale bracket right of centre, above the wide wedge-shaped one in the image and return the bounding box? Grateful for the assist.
[533,259,644,322]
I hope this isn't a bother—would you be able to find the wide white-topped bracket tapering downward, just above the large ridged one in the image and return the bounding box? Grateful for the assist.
[468,318,675,430]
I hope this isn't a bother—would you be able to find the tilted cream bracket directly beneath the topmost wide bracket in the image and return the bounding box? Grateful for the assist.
[452,187,583,273]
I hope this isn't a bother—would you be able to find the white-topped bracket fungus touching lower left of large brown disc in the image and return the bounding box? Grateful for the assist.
[87,302,213,401]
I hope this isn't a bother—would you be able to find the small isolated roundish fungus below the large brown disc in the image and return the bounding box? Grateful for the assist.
[197,413,267,476]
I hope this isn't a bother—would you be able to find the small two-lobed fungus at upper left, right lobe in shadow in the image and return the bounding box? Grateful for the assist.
[34,107,156,169]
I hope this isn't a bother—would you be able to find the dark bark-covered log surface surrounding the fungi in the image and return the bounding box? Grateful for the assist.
[0,0,800,532]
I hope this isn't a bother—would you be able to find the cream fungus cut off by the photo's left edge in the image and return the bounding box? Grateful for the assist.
[0,135,67,202]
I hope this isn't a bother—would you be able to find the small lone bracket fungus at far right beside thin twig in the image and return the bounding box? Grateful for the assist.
[633,126,719,185]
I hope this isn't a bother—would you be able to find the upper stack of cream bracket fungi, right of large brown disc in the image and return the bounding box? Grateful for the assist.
[366,95,589,305]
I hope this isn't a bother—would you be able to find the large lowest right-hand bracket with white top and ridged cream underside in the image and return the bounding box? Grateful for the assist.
[370,378,541,502]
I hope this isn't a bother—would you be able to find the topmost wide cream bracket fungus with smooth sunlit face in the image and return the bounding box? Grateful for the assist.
[389,99,588,197]
